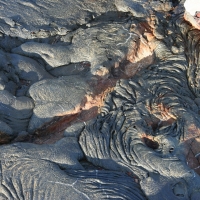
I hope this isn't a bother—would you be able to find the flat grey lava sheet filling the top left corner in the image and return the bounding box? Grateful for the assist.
[0,0,116,39]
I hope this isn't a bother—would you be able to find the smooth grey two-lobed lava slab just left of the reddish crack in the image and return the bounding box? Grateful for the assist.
[28,76,90,132]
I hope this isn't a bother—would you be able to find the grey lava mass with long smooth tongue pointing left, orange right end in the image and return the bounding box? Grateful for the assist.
[12,20,153,75]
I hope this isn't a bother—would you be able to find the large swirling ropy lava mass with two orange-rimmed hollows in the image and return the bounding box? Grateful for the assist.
[79,13,200,199]
